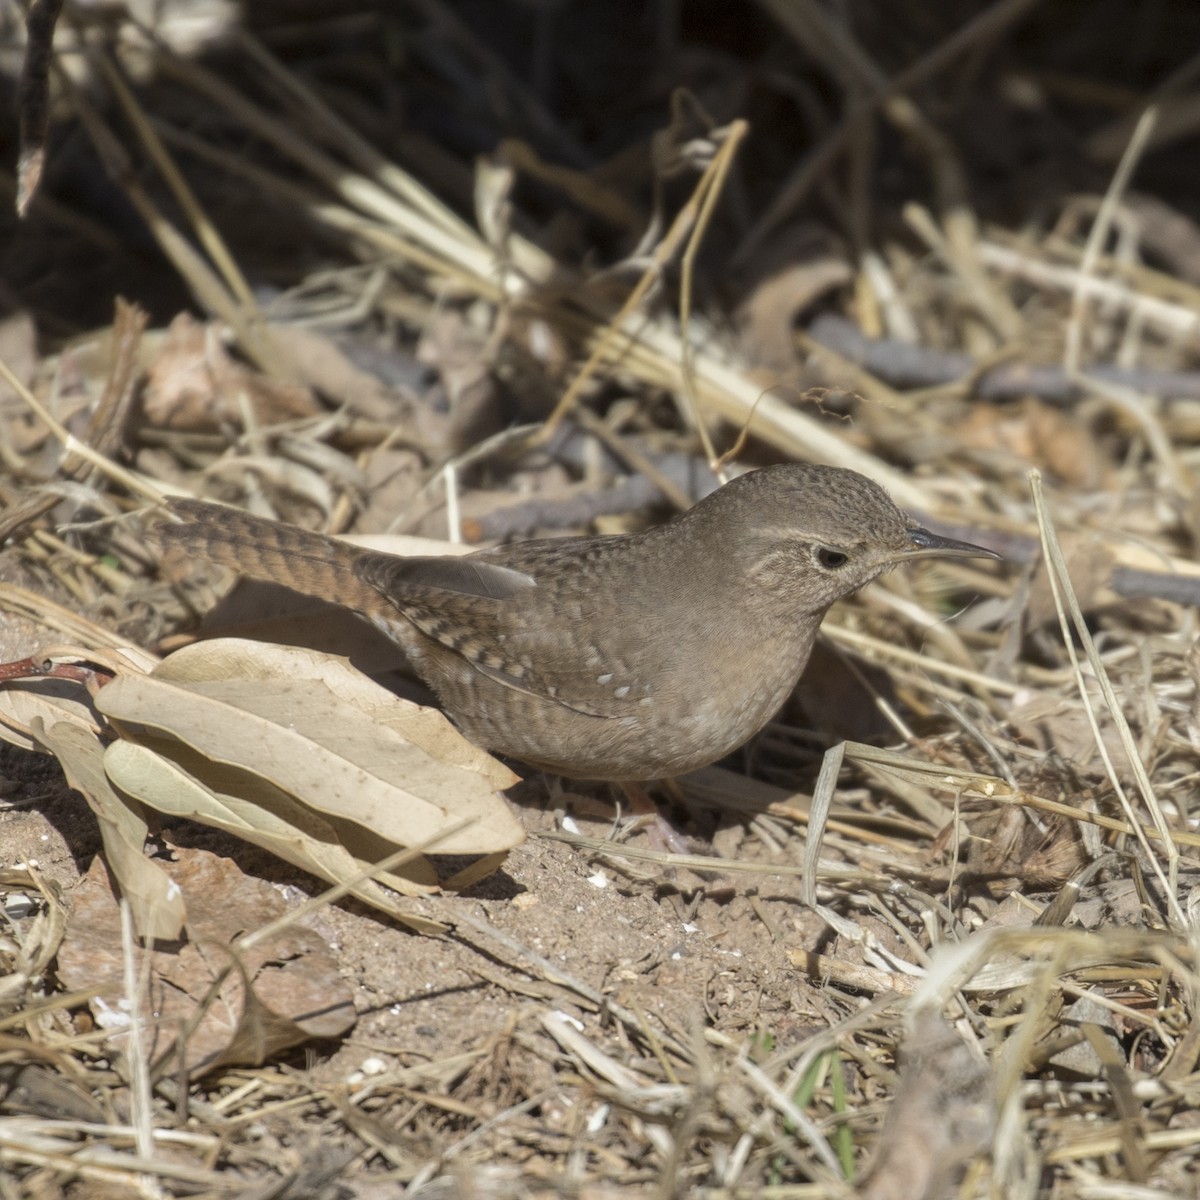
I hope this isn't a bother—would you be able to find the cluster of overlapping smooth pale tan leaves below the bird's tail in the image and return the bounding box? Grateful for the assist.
[64,640,524,934]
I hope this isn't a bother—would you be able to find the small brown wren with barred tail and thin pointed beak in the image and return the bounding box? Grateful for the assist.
[156,463,1000,784]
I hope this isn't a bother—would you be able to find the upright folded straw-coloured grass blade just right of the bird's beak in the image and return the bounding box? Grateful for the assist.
[1028,470,1188,930]
